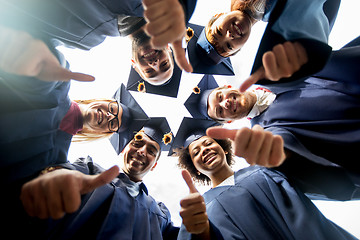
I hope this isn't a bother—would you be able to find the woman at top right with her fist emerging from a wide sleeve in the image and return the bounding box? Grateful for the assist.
[198,0,340,91]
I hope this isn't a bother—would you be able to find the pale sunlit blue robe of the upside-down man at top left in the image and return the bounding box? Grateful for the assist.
[0,0,196,50]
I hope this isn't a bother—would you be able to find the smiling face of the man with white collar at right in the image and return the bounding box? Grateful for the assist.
[208,88,251,120]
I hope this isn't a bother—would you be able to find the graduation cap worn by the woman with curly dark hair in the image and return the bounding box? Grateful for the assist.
[169,117,221,156]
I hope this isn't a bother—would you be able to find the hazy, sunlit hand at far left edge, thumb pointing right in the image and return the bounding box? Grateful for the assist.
[0,26,94,81]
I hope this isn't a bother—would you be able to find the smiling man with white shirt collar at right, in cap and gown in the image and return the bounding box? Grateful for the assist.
[185,38,360,200]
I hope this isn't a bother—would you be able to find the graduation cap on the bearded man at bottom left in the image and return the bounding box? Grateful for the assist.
[142,117,173,151]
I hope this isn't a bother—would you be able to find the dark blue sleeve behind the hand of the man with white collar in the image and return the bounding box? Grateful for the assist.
[266,127,360,201]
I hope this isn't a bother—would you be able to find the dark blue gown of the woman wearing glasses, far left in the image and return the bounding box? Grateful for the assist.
[0,47,72,184]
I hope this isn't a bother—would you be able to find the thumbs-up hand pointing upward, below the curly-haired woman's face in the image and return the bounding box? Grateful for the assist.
[180,170,210,239]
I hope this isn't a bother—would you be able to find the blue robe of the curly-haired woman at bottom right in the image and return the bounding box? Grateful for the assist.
[179,166,356,240]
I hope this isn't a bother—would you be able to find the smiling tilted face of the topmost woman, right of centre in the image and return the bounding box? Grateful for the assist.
[206,11,252,57]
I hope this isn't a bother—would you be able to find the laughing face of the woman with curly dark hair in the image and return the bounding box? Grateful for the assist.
[189,136,227,176]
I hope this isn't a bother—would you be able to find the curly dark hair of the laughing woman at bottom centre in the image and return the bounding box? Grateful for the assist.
[175,139,234,185]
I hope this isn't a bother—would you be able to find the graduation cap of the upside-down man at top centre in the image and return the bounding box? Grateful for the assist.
[126,61,182,97]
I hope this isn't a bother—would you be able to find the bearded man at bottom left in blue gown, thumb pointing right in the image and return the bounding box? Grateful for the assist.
[21,118,179,239]
